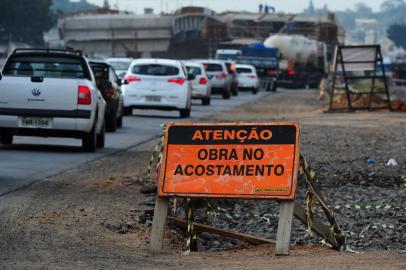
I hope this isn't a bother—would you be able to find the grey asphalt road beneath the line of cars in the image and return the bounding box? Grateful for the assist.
[0,91,270,196]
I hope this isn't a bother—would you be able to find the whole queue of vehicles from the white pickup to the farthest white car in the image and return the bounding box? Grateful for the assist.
[0,49,259,152]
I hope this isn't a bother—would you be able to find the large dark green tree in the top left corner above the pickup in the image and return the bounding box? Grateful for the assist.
[0,0,56,46]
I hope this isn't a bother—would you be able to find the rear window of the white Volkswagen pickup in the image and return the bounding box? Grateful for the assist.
[3,56,86,78]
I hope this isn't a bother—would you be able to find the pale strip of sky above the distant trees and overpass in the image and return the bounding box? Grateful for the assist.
[88,0,385,13]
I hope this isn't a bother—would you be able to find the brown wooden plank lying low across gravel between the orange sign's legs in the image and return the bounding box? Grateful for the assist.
[173,218,275,245]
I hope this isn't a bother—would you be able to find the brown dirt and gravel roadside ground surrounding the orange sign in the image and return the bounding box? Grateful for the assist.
[0,90,406,270]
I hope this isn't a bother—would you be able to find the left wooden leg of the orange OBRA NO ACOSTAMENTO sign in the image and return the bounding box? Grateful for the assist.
[149,196,169,254]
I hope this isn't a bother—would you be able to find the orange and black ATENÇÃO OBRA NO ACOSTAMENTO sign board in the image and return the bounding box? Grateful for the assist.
[159,123,299,199]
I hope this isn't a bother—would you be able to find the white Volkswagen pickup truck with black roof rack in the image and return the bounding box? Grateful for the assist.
[0,49,106,152]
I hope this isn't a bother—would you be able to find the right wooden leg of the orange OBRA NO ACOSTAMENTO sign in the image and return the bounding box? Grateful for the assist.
[275,201,295,255]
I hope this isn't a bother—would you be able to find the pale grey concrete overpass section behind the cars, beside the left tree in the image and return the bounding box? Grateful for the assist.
[59,14,172,57]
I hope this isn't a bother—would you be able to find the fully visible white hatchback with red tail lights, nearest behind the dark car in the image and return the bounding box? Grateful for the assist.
[123,59,195,118]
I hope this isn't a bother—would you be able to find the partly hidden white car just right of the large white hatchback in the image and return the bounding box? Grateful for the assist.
[185,62,211,105]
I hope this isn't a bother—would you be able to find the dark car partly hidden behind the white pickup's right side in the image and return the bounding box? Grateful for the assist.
[89,60,124,131]
